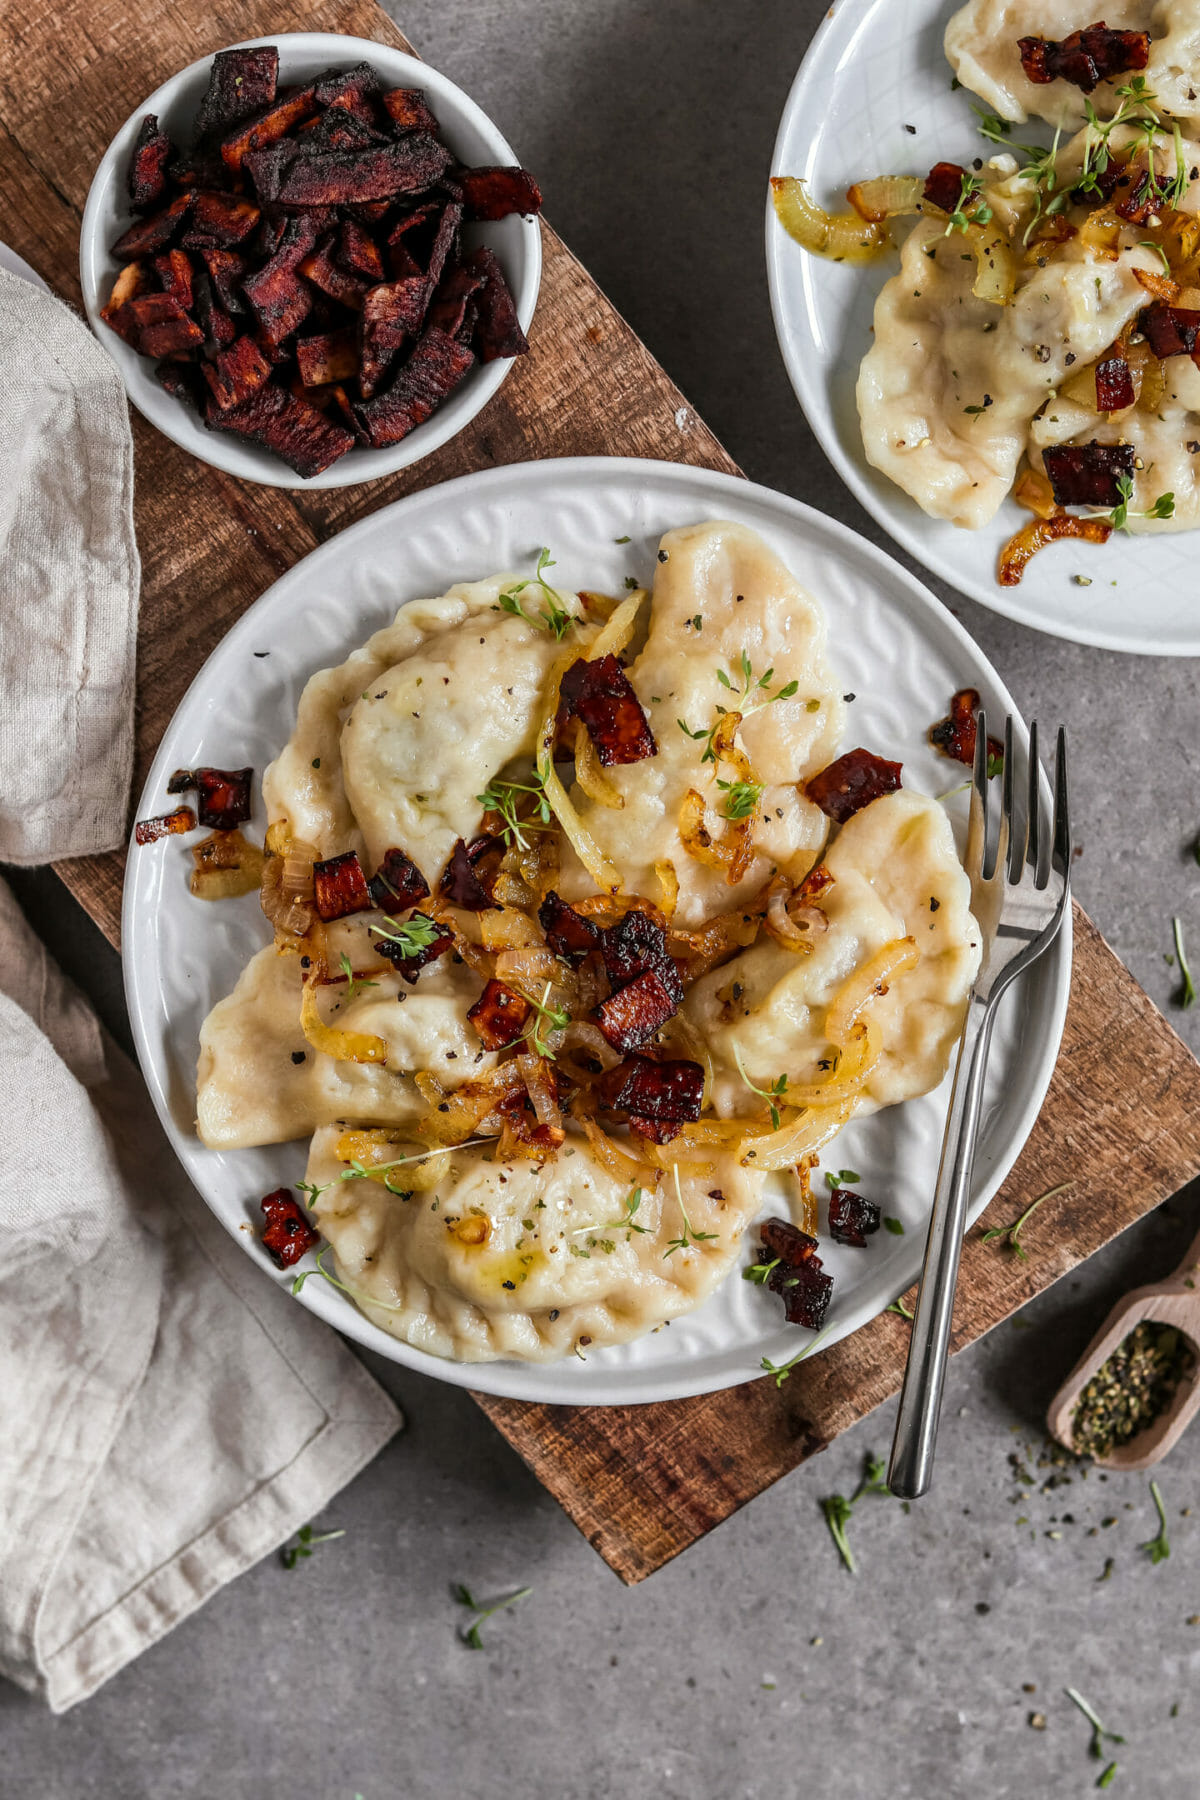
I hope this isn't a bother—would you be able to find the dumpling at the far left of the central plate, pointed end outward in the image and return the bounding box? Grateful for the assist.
[196,947,495,1150]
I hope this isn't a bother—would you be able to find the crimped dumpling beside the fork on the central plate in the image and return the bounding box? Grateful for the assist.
[685,788,981,1112]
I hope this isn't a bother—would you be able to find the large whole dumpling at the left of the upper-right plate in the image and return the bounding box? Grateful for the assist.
[858,185,1162,529]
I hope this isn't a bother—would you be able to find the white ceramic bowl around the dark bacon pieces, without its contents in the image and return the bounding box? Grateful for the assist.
[79,31,542,488]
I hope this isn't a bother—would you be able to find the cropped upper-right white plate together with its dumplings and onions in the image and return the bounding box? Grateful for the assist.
[766,0,1200,655]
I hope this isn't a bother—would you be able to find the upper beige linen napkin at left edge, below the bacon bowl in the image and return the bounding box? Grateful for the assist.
[0,266,140,862]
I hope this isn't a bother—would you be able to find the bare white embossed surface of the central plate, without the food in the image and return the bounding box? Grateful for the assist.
[122,457,1070,1404]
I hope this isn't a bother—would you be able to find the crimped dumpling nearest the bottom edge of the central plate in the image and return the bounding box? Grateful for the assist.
[306,1125,763,1363]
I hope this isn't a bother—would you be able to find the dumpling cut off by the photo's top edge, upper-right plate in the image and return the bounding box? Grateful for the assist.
[945,0,1200,131]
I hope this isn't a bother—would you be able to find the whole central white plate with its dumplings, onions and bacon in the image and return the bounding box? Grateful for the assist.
[124,459,1070,1404]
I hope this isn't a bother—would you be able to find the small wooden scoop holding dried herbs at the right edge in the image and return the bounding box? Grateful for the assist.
[1045,1237,1200,1469]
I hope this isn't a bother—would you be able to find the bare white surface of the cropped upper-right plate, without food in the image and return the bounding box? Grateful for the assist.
[766,0,1200,657]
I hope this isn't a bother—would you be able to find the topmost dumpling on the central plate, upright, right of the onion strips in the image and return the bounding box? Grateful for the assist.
[561,522,846,927]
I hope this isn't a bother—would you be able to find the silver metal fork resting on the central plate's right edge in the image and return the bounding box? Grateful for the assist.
[887,711,1070,1499]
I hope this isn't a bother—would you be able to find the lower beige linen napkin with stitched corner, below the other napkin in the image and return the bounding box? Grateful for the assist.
[0,882,401,1712]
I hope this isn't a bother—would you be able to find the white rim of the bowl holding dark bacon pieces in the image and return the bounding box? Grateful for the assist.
[79,31,542,493]
